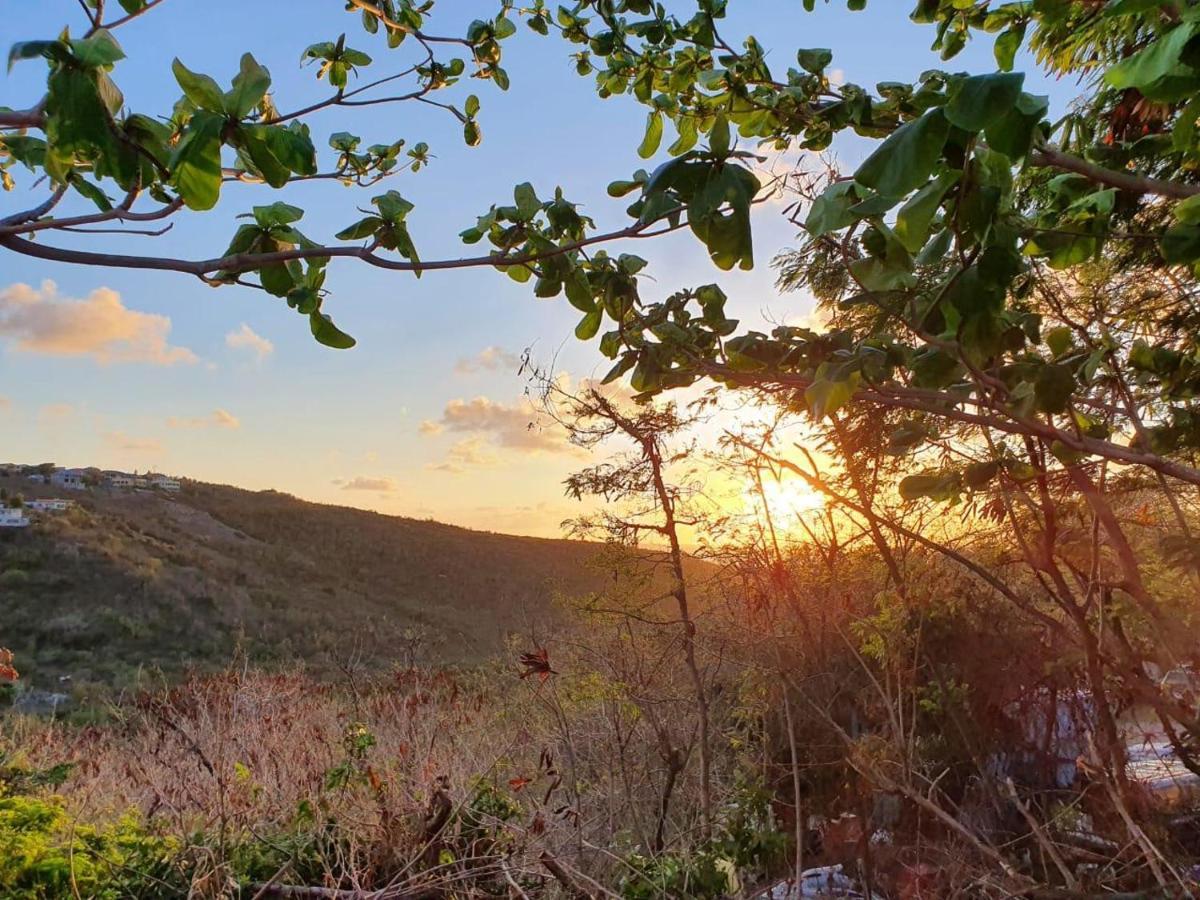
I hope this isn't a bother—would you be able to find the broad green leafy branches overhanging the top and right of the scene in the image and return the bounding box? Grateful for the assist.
[0,0,1200,487]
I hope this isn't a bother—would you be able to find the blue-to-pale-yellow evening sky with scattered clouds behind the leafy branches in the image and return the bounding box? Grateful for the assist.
[0,0,1072,536]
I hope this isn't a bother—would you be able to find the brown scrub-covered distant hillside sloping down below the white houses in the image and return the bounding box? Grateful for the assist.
[0,479,672,686]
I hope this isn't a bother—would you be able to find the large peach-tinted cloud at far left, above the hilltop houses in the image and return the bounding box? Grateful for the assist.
[0,281,197,366]
